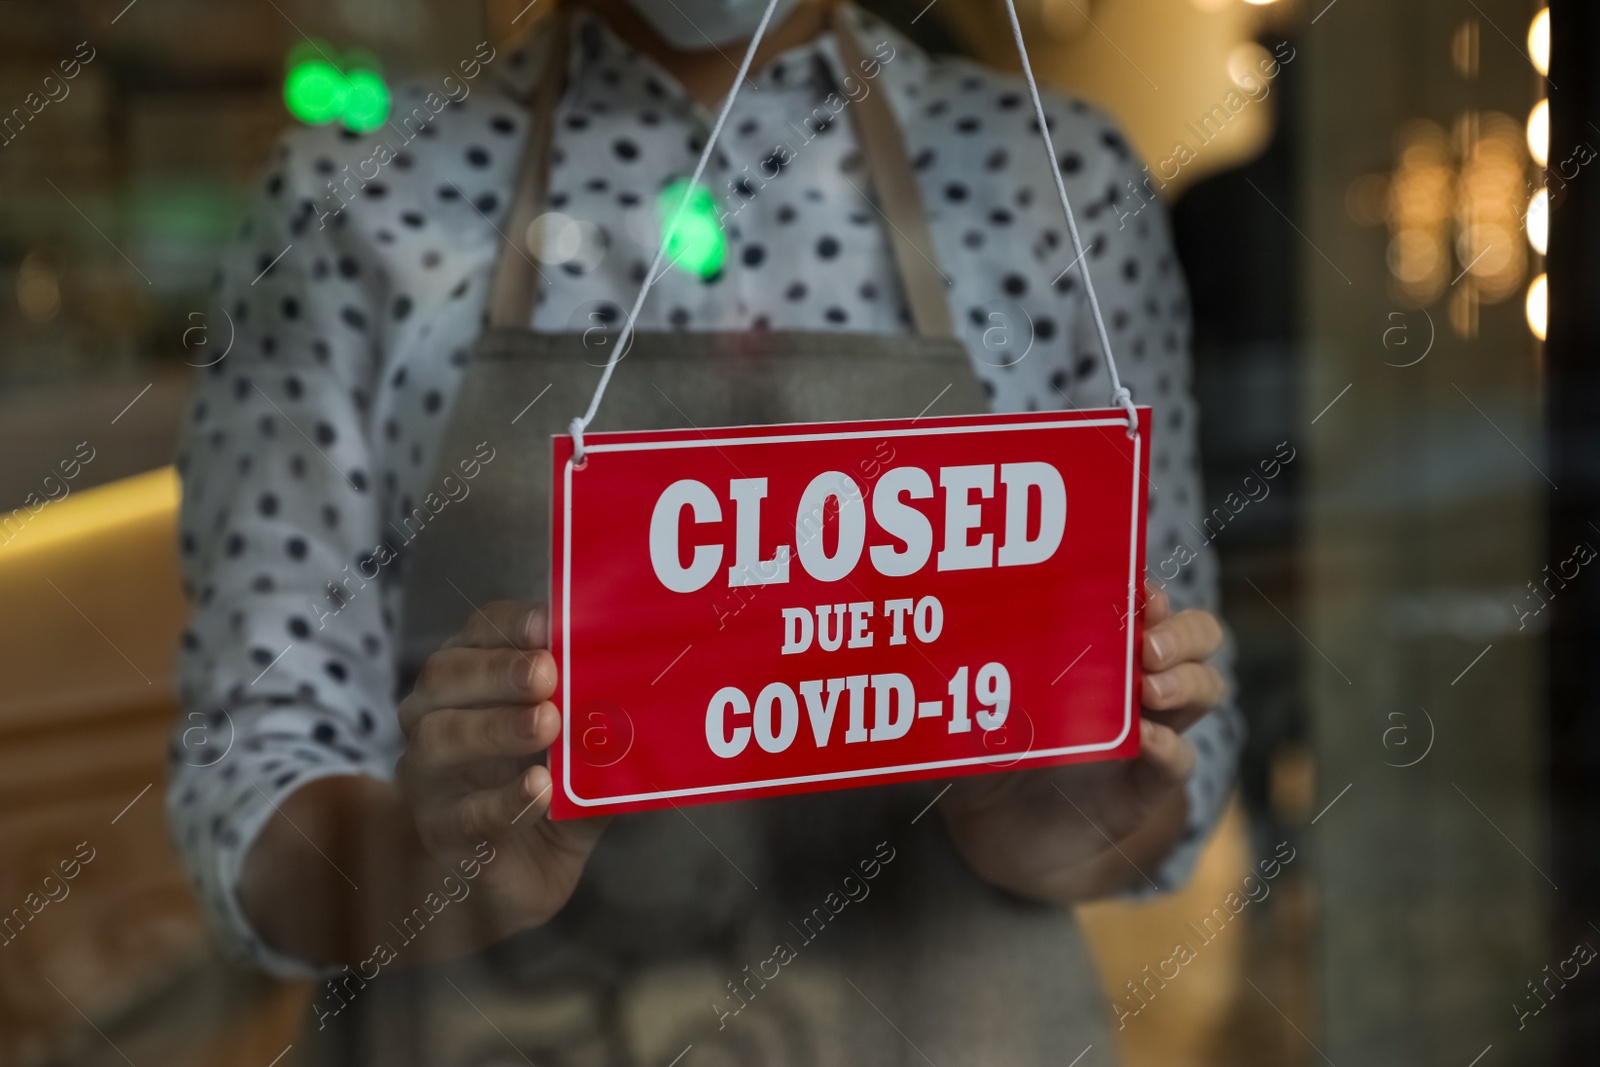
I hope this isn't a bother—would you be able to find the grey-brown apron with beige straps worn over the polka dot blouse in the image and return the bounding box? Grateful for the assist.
[307,10,1112,1067]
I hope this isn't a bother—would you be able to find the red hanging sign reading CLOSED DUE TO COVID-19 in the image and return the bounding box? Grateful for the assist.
[550,408,1150,819]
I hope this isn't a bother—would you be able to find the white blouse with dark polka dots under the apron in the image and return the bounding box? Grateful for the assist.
[168,6,1243,974]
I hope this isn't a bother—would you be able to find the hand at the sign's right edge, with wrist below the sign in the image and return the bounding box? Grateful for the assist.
[939,585,1226,902]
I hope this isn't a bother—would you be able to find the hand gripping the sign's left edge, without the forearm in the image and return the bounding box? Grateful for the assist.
[395,601,608,936]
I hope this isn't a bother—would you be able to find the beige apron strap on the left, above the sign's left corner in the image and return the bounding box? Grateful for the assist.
[490,10,571,330]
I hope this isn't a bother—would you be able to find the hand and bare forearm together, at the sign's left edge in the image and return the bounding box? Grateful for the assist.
[238,603,606,969]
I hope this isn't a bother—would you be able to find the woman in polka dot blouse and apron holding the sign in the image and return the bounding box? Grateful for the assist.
[170,0,1242,1064]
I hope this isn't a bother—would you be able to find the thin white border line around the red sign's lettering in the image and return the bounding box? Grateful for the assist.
[562,416,1144,808]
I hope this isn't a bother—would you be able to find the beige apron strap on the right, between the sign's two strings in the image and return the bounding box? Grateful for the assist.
[834,3,955,338]
